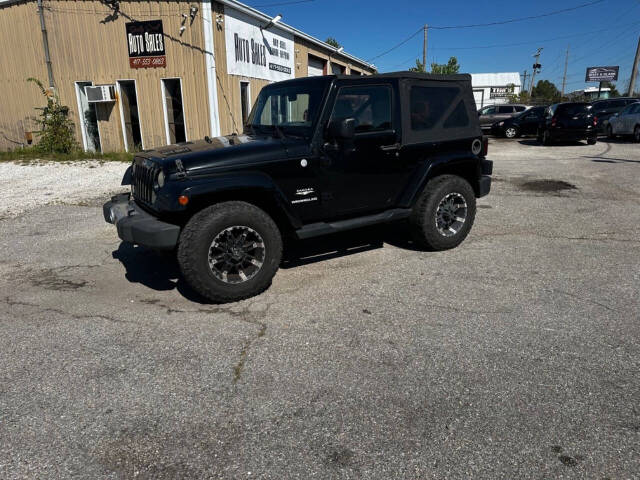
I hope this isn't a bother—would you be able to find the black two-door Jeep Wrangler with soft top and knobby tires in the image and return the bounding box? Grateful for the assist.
[104,72,492,302]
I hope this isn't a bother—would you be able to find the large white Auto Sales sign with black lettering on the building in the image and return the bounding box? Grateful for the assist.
[224,9,295,82]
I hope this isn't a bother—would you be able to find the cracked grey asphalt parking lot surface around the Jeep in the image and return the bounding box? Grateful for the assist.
[0,139,640,479]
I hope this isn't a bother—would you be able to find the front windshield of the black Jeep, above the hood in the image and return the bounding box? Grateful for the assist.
[247,84,324,137]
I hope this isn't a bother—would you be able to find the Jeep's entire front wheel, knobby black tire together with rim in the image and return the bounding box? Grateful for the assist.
[178,201,282,303]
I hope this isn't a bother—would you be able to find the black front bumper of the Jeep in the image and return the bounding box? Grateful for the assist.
[102,193,180,250]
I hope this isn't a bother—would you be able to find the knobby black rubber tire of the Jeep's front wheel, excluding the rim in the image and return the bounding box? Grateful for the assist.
[177,201,282,303]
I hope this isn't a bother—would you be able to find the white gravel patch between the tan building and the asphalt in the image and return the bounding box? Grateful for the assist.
[0,160,128,218]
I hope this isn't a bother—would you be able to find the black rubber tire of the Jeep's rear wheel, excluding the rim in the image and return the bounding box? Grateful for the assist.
[409,175,476,251]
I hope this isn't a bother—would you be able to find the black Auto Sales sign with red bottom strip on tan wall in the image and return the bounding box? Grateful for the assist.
[125,20,167,68]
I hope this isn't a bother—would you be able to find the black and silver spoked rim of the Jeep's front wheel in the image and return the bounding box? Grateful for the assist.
[209,226,265,284]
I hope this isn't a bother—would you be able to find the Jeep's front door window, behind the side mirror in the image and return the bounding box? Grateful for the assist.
[331,86,391,133]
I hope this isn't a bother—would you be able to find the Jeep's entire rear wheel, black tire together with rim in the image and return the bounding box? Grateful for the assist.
[409,175,476,251]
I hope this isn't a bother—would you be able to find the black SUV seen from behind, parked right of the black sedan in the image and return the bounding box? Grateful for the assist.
[537,102,598,145]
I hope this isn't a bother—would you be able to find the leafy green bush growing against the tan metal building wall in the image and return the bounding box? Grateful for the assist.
[27,78,79,153]
